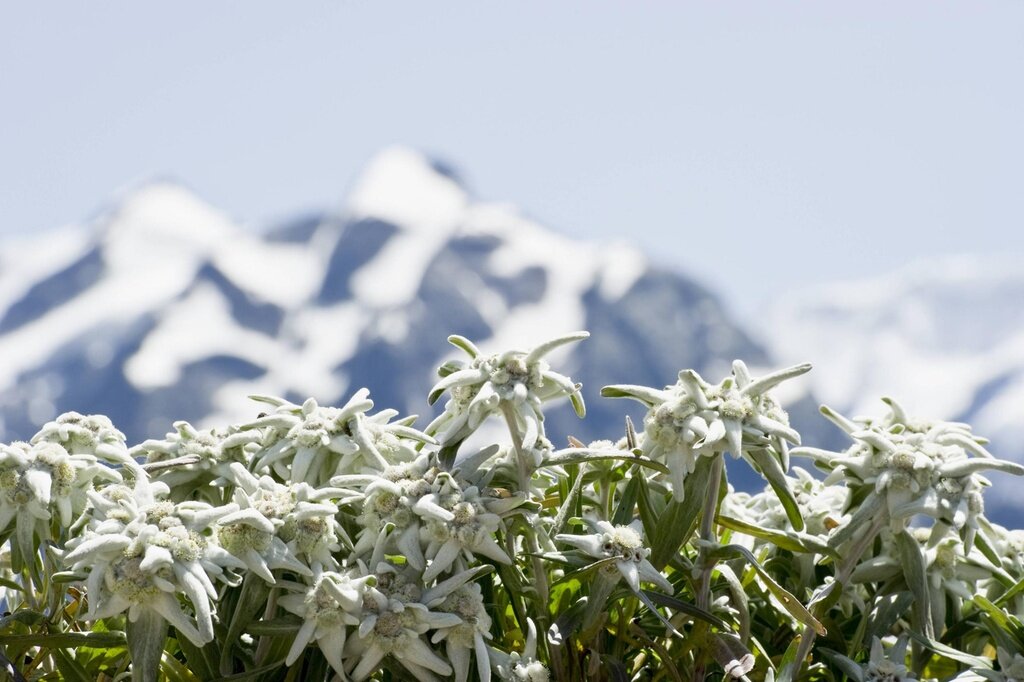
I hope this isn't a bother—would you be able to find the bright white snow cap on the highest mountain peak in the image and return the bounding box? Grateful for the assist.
[348,145,469,231]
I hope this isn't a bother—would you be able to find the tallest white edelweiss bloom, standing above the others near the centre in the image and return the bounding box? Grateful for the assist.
[427,332,590,450]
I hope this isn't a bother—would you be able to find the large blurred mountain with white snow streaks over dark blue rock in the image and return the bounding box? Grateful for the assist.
[0,148,790,489]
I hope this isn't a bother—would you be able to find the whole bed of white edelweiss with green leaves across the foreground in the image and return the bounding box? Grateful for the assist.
[0,332,1024,682]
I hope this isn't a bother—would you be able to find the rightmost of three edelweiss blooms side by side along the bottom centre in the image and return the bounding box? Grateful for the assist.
[428,583,490,682]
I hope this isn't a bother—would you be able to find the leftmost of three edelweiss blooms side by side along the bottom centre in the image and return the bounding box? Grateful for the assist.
[279,565,377,679]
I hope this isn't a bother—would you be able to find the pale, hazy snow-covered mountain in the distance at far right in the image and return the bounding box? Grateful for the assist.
[763,256,1024,516]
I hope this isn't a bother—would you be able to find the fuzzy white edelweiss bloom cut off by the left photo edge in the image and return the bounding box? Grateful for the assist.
[0,439,121,562]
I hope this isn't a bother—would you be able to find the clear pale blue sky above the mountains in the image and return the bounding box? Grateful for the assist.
[0,0,1024,312]
